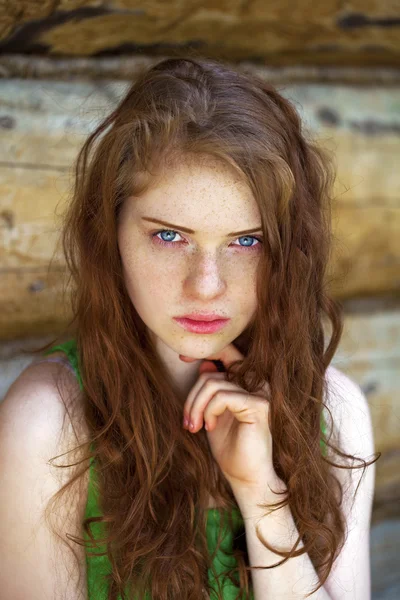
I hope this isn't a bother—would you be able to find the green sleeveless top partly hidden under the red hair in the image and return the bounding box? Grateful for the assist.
[44,339,325,600]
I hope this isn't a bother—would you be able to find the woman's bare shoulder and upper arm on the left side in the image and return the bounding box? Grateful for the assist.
[0,353,88,600]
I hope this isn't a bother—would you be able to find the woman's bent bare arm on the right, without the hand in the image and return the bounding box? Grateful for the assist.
[235,367,375,600]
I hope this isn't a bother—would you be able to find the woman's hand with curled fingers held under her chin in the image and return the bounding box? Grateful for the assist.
[179,344,280,493]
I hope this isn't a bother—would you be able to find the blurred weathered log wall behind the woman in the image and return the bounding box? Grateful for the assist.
[0,0,400,600]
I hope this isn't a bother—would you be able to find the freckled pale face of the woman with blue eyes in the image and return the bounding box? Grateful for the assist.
[118,157,263,359]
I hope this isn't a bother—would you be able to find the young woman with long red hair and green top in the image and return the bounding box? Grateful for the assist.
[0,58,379,600]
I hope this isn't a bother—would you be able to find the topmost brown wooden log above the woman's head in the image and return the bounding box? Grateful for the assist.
[0,0,400,66]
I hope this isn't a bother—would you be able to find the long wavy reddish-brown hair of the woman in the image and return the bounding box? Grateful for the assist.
[29,57,379,600]
